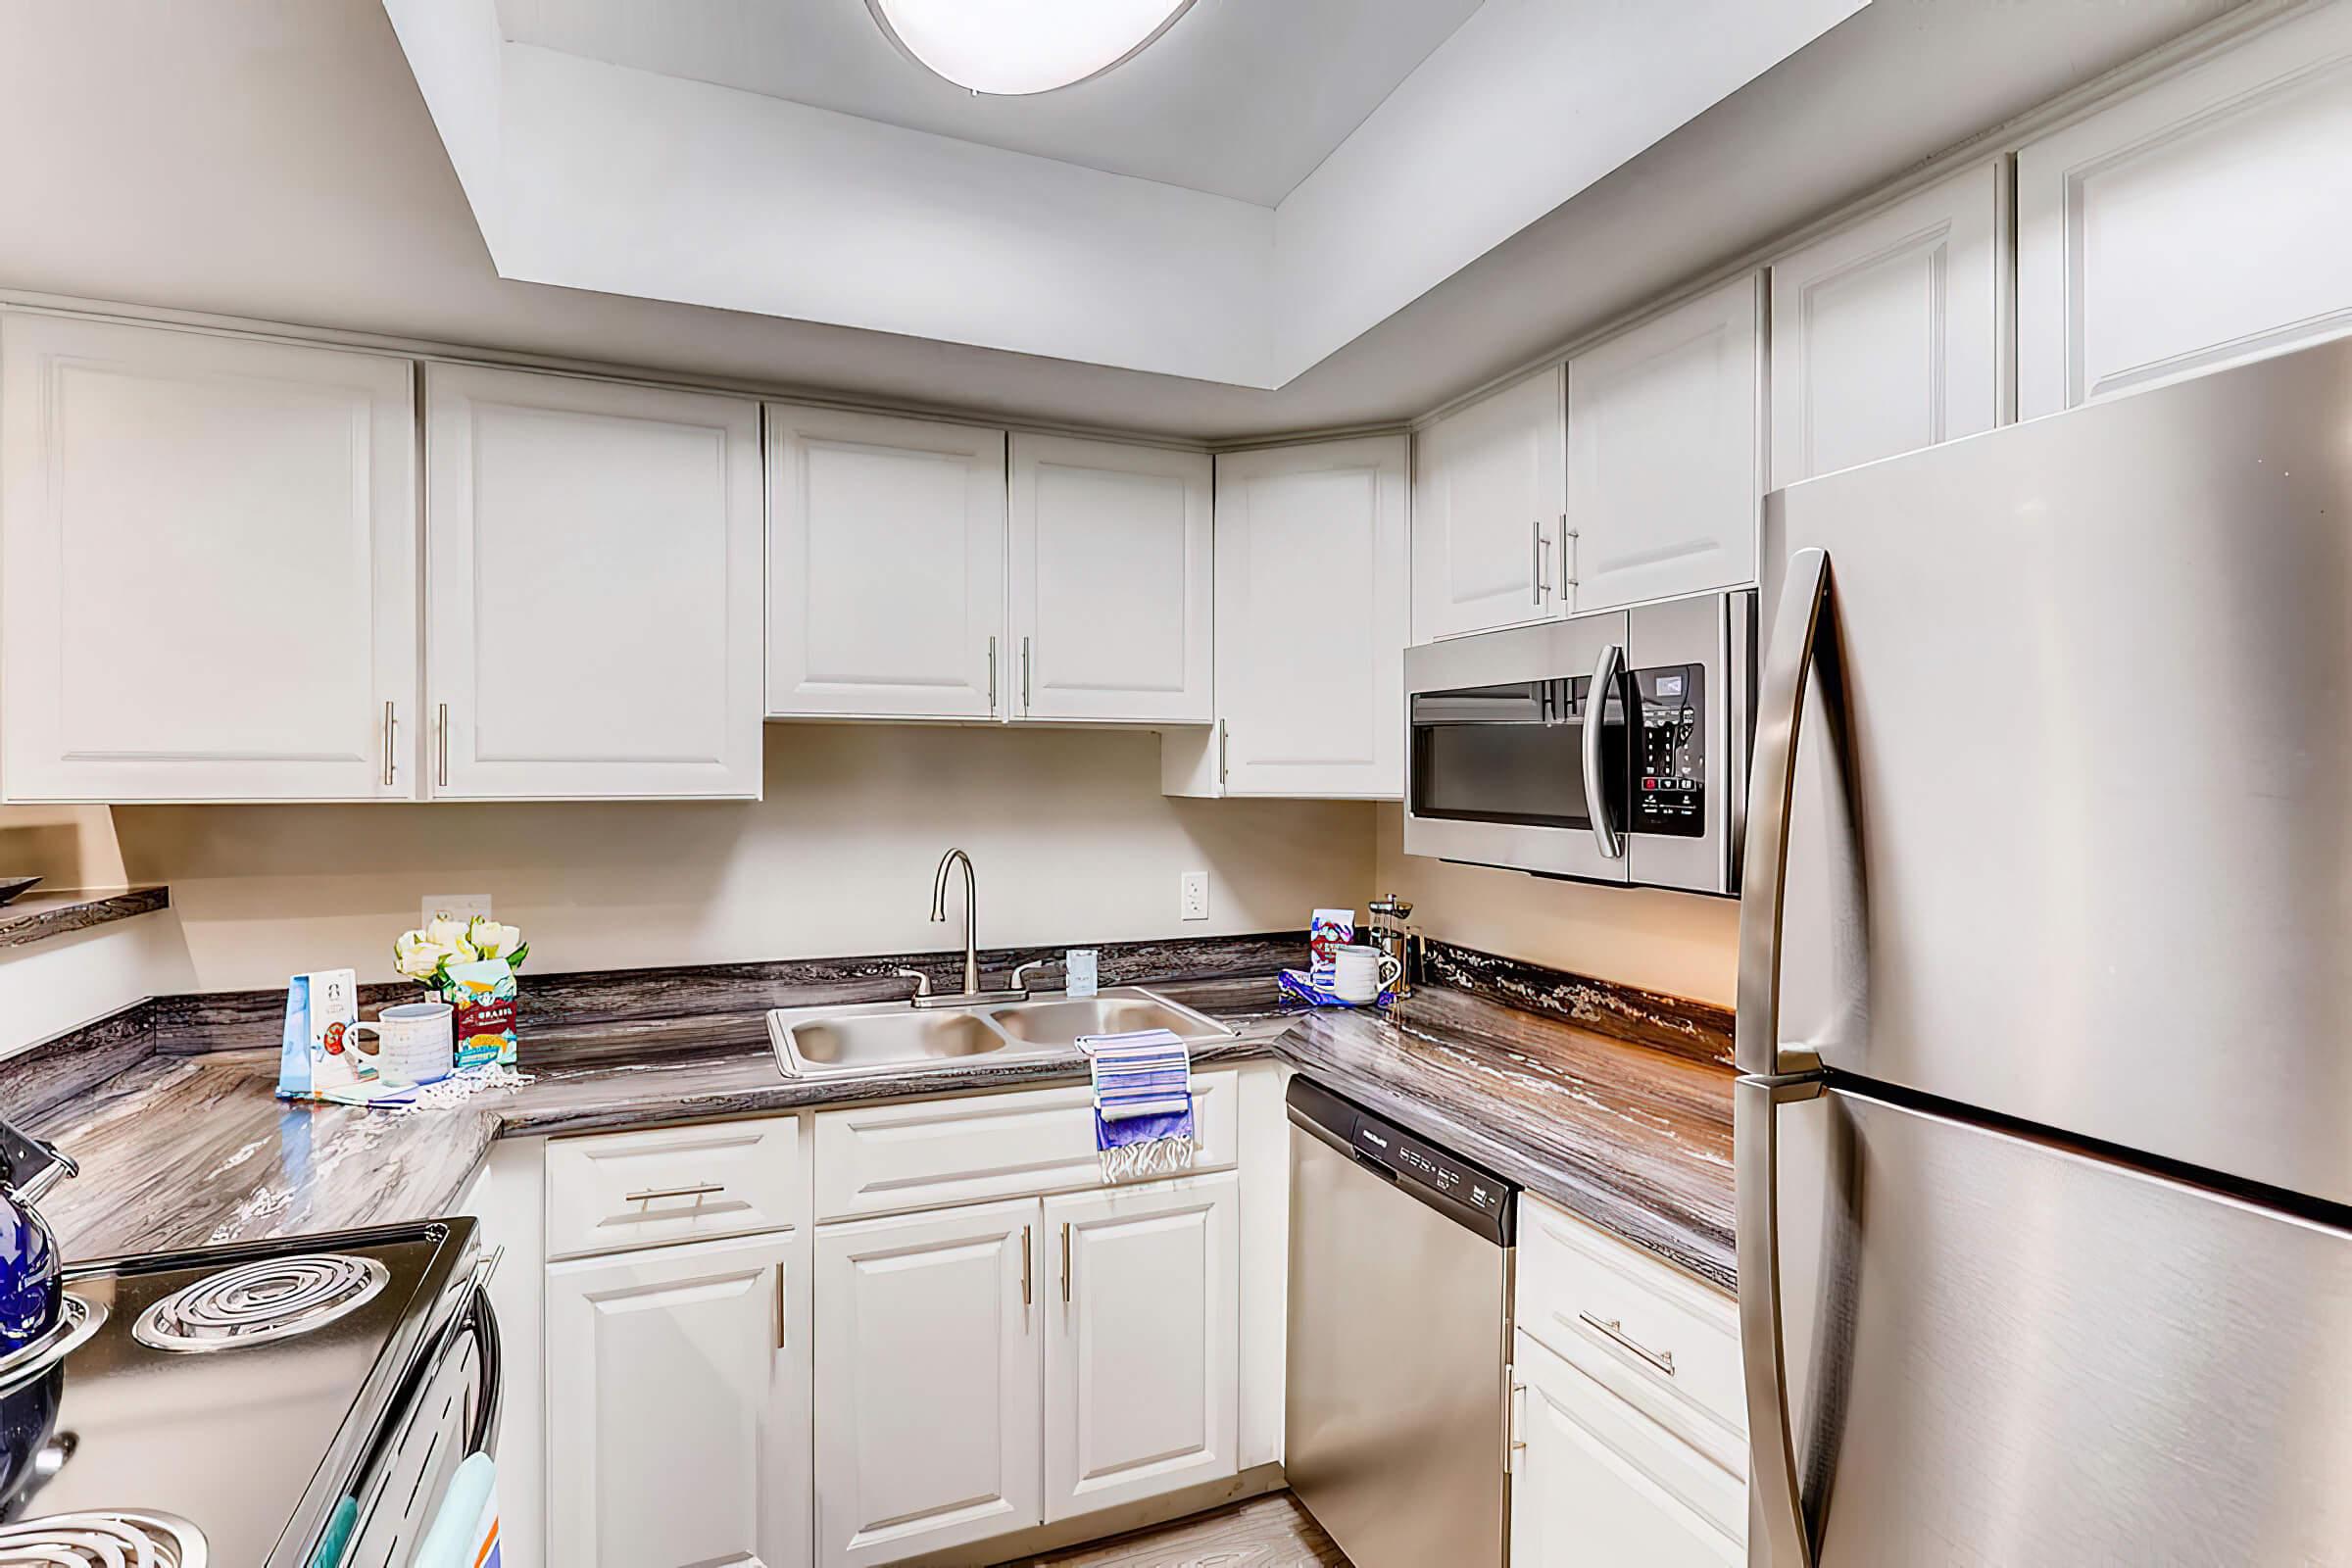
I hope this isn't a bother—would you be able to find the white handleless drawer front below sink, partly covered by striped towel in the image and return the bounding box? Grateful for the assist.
[816,1067,1237,1220]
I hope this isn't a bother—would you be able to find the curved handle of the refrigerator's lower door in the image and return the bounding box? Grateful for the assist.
[1731,1079,1823,1568]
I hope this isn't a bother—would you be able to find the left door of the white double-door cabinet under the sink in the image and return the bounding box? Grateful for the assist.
[816,1199,1052,1566]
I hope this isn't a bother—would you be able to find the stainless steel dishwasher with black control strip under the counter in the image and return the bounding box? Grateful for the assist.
[1282,1077,1517,1568]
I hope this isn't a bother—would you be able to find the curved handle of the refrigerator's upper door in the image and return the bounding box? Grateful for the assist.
[1734,548,1830,1077]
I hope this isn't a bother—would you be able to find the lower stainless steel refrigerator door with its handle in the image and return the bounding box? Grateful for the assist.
[1739,1079,2352,1568]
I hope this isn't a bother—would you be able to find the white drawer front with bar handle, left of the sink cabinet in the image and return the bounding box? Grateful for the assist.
[548,1116,802,1257]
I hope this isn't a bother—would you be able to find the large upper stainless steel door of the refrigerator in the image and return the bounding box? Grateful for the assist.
[1740,341,2352,1203]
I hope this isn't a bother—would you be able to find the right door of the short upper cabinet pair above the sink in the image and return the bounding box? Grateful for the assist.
[1009,435,1213,724]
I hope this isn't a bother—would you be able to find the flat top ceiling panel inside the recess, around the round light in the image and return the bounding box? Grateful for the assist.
[499,0,1480,207]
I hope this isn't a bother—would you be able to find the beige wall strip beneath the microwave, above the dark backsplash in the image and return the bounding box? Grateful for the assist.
[1374,807,1740,1006]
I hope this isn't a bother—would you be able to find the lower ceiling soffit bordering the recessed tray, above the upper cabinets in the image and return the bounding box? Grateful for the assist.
[0,0,2234,442]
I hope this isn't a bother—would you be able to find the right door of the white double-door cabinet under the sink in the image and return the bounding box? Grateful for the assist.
[1045,1173,1240,1519]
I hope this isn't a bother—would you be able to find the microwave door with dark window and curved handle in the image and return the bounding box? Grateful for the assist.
[1404,613,1633,882]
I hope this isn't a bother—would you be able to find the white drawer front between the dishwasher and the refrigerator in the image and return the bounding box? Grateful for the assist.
[1512,1197,1747,1474]
